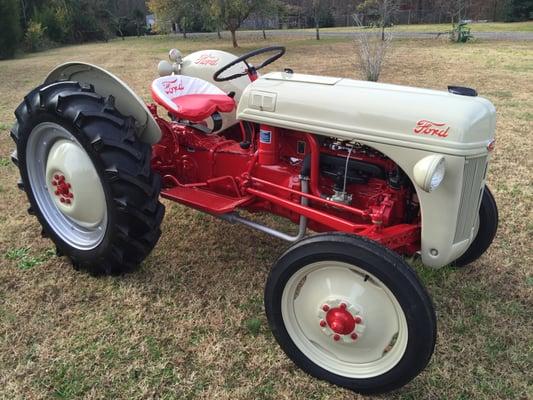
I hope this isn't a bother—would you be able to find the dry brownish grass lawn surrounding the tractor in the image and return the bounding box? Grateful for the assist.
[0,36,533,400]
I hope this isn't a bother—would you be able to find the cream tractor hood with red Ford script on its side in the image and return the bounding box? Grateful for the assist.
[237,72,496,155]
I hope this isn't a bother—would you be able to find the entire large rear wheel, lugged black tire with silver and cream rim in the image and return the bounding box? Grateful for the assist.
[11,81,164,275]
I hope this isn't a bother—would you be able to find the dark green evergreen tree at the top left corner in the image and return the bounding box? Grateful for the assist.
[0,0,21,59]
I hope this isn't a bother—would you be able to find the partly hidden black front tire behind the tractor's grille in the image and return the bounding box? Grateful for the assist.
[453,186,498,267]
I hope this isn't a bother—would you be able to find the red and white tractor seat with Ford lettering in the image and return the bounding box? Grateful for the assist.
[151,75,235,122]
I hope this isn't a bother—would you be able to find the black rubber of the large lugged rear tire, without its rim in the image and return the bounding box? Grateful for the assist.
[11,81,164,275]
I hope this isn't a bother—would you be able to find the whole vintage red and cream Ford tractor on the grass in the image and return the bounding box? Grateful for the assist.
[12,47,498,393]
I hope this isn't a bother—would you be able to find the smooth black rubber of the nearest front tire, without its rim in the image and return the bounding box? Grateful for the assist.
[265,233,437,394]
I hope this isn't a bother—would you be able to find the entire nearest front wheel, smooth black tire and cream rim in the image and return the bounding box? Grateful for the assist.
[265,233,436,394]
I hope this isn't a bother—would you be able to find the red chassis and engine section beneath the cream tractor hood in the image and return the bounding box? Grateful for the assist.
[149,105,420,255]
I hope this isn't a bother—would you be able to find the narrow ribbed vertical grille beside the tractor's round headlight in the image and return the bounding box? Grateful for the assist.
[453,156,487,243]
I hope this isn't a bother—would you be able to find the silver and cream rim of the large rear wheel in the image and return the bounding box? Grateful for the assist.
[26,122,107,250]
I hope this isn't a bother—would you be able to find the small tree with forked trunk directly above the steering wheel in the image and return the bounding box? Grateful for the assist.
[211,0,262,47]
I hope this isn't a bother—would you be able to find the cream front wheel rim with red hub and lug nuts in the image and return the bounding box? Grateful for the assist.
[281,261,408,379]
